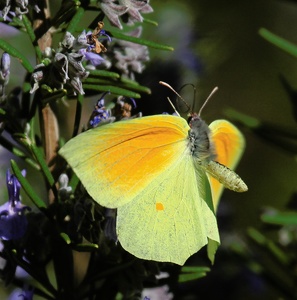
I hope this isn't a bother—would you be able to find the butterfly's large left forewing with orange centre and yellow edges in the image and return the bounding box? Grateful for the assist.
[59,115,189,208]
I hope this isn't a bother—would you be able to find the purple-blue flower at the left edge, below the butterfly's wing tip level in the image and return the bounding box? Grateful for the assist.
[0,170,30,240]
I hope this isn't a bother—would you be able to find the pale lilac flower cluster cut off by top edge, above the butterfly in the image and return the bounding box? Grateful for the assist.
[99,0,153,29]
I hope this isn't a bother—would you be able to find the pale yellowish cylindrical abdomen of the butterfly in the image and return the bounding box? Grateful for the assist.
[204,161,248,192]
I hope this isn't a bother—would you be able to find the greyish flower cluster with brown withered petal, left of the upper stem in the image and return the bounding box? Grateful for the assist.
[31,22,110,95]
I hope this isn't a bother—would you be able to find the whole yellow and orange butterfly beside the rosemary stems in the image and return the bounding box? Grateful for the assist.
[59,90,247,265]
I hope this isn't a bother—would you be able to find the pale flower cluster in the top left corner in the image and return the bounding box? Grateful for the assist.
[0,0,40,21]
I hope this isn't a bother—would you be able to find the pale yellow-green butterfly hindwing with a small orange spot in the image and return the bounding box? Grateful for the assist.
[117,141,219,265]
